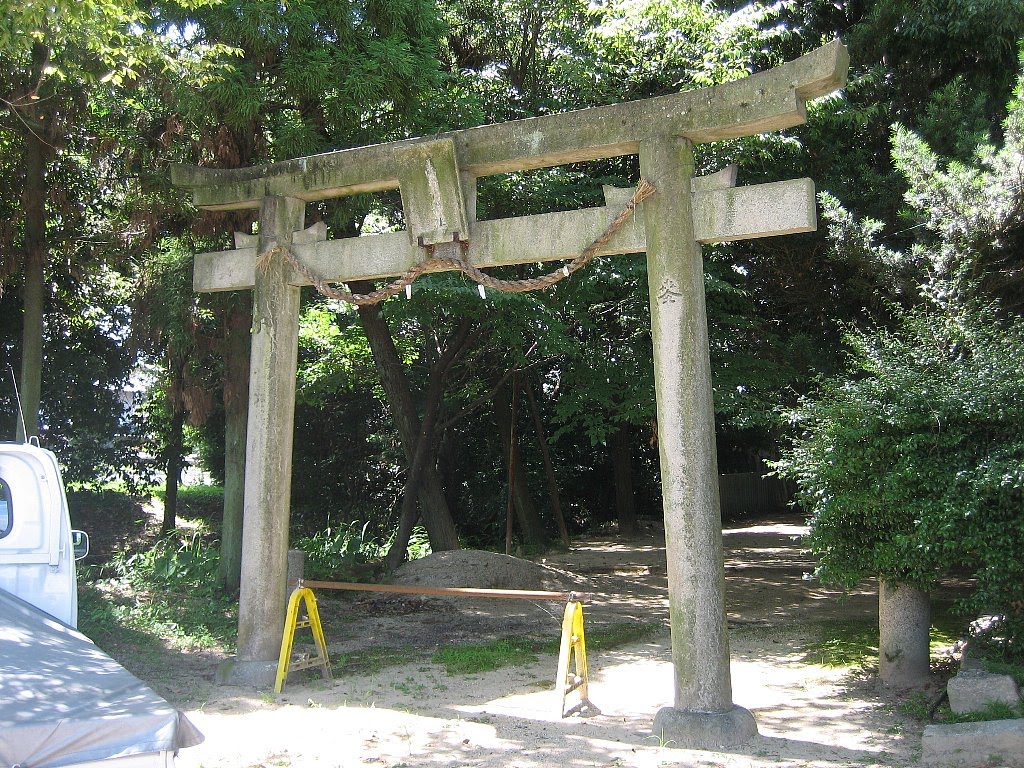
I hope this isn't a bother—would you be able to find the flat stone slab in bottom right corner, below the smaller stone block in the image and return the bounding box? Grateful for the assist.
[921,719,1024,768]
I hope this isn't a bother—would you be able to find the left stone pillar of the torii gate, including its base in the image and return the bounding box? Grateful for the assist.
[218,197,305,687]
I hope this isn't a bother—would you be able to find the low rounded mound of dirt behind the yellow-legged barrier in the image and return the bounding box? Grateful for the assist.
[391,549,573,592]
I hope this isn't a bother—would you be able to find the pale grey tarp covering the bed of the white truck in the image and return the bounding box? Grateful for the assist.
[0,590,203,768]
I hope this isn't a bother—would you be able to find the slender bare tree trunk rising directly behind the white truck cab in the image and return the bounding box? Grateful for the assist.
[16,64,49,441]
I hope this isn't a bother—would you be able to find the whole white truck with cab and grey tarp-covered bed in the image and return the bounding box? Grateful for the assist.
[0,442,203,768]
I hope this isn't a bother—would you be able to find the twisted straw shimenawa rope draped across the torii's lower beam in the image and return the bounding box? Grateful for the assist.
[256,179,654,305]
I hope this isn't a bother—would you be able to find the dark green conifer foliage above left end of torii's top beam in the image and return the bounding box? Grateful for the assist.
[161,0,440,166]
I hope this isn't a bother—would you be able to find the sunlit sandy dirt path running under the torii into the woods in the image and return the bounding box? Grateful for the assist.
[161,519,921,768]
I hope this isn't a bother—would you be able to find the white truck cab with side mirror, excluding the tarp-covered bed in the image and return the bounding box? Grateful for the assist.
[0,442,88,627]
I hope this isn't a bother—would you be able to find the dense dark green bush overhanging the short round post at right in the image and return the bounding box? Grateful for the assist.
[777,307,1024,653]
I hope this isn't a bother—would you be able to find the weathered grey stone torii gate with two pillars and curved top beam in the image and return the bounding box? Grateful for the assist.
[172,41,849,748]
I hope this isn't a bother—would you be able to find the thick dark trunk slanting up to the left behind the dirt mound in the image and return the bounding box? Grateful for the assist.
[350,282,459,552]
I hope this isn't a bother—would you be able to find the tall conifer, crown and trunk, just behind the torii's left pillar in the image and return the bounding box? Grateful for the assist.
[147,0,438,590]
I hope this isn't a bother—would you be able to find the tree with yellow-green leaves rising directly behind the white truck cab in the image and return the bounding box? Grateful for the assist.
[0,0,226,437]
